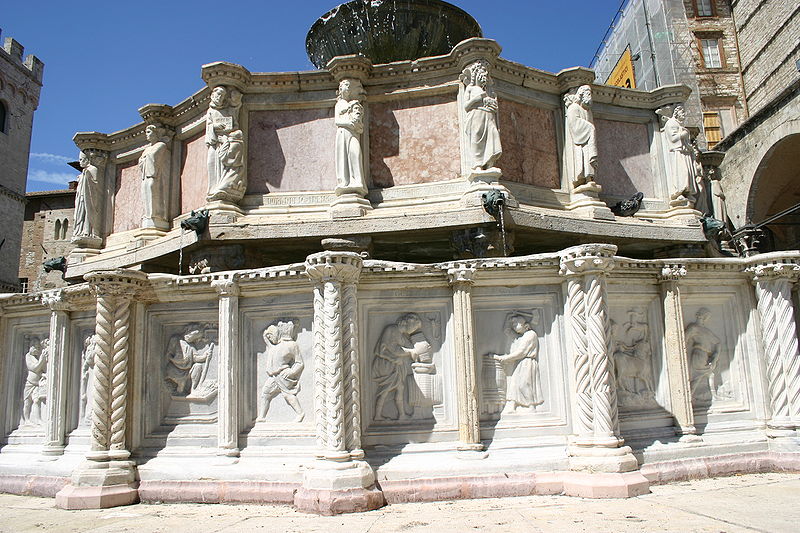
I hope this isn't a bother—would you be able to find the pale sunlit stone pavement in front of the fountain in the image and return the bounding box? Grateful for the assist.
[0,474,800,533]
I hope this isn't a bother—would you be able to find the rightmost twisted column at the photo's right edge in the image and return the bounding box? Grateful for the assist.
[749,261,800,437]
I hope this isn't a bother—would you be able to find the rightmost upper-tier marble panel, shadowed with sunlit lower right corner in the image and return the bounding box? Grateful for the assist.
[594,119,655,198]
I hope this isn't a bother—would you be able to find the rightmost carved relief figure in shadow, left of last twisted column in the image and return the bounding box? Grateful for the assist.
[685,307,722,401]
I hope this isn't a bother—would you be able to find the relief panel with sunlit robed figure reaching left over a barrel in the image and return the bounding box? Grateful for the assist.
[473,286,567,427]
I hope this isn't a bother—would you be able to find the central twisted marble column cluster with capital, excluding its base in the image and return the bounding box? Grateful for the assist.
[306,252,363,461]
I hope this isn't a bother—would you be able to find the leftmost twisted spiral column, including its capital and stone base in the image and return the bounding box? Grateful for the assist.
[56,270,147,509]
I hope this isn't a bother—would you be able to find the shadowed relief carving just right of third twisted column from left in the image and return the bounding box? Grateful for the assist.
[612,308,655,404]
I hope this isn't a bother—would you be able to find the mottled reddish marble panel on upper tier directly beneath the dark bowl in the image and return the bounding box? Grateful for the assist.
[369,96,461,187]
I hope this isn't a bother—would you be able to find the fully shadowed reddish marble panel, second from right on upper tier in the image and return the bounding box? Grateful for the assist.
[497,100,561,189]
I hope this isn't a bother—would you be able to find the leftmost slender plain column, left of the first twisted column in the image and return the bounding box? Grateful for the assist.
[42,290,70,456]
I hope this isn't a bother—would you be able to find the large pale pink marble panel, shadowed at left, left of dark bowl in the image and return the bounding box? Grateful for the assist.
[247,108,336,194]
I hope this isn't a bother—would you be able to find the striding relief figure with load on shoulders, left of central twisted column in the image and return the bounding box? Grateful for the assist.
[258,320,305,423]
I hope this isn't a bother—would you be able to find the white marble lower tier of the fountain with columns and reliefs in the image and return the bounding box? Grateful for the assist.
[0,248,800,510]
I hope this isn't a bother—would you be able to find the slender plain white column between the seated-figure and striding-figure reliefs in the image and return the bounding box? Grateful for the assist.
[211,278,240,457]
